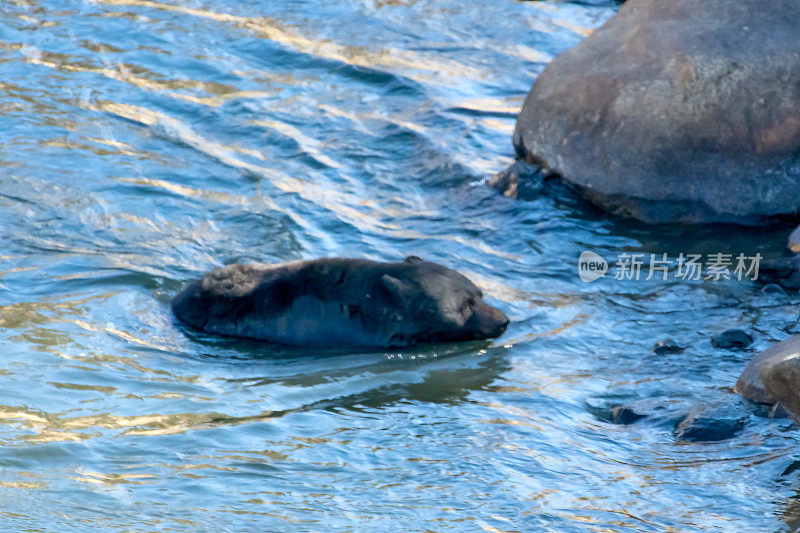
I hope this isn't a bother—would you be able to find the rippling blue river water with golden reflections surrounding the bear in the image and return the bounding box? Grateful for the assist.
[0,0,800,532]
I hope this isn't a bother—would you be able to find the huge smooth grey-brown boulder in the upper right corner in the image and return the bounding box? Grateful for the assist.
[514,0,800,223]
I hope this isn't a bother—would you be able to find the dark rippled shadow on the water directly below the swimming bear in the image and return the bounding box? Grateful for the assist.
[187,332,511,412]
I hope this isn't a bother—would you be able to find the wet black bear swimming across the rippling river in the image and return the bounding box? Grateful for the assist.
[172,256,508,347]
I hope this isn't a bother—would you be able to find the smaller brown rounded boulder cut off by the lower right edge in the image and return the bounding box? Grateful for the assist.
[734,335,800,421]
